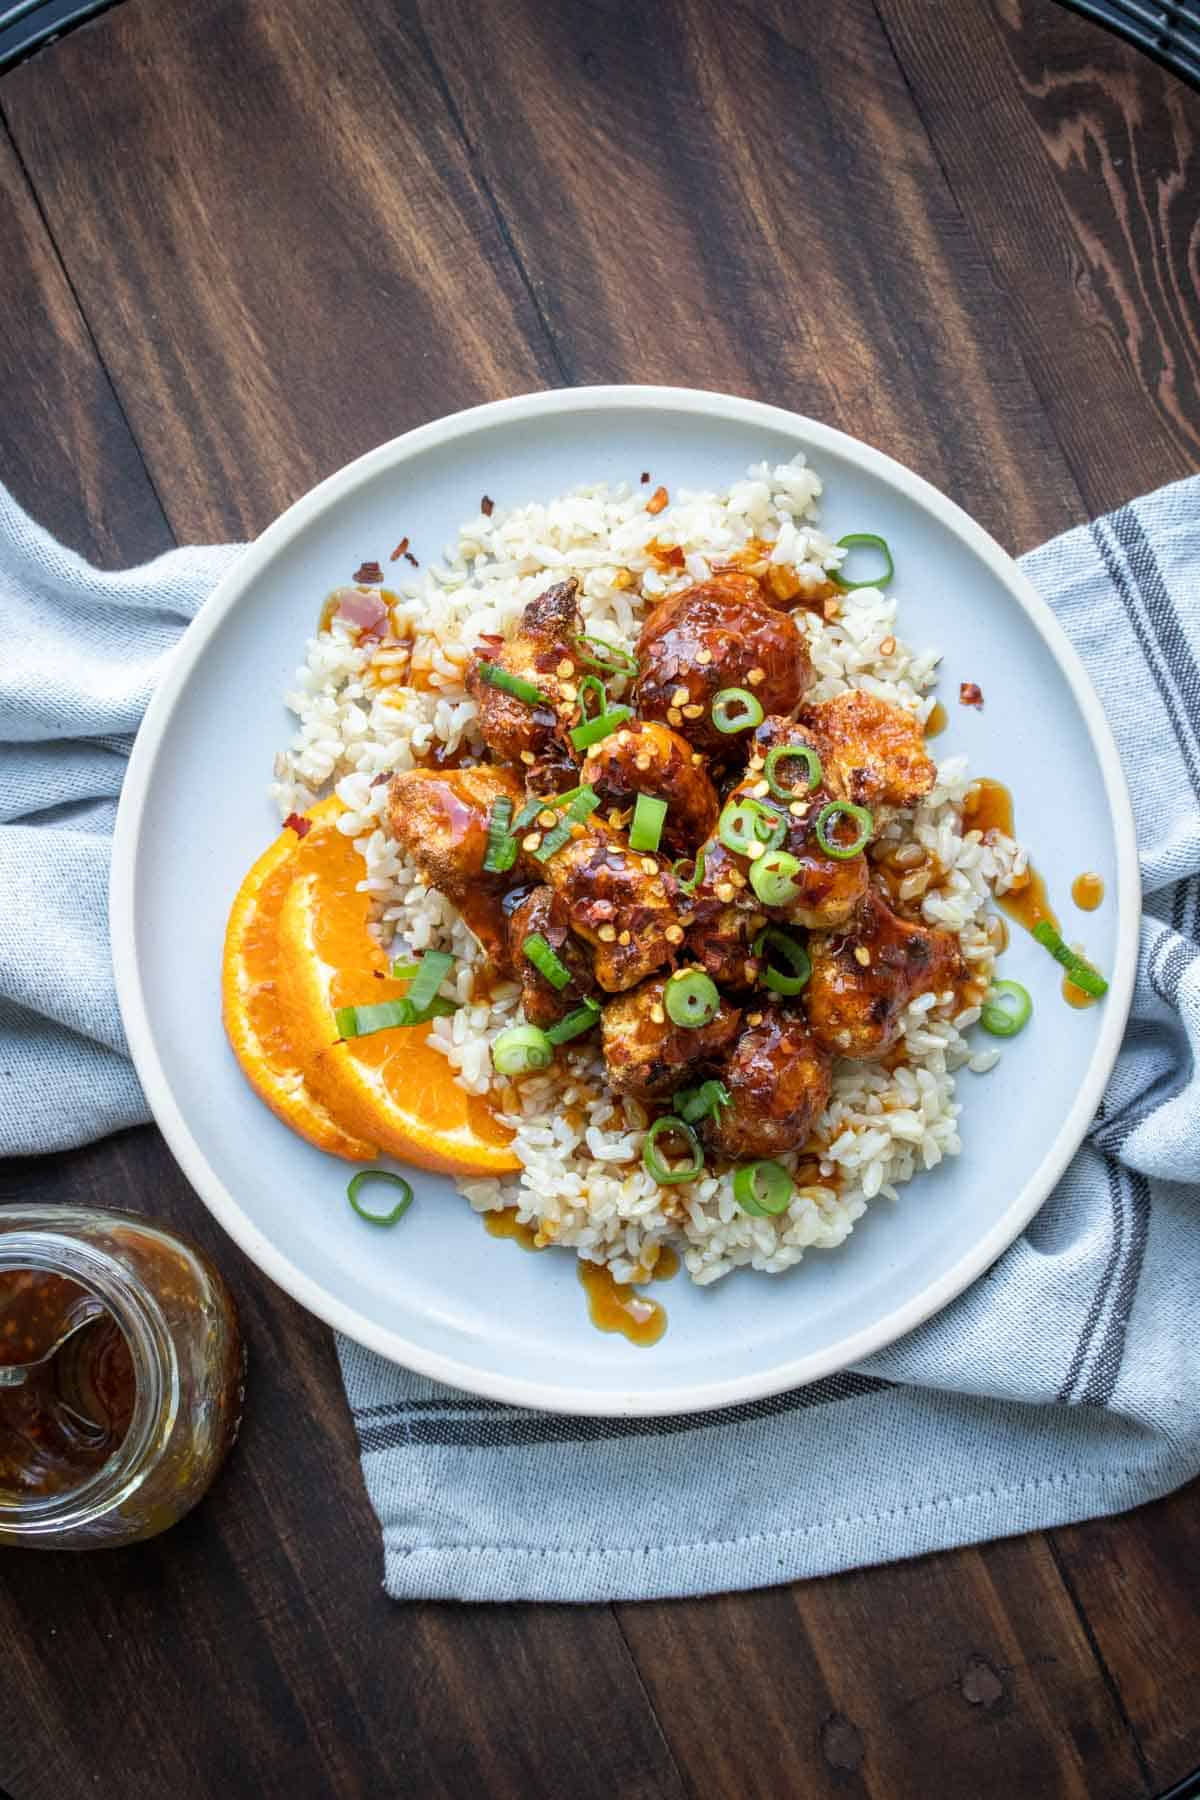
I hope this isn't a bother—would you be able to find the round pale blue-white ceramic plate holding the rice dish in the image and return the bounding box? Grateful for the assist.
[112,387,1139,1415]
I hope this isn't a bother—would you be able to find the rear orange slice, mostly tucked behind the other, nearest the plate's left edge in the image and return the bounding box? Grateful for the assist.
[221,797,378,1163]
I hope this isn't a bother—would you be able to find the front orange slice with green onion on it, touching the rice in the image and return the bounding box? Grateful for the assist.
[279,873,520,1175]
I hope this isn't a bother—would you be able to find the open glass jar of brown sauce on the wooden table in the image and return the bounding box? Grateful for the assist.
[0,1204,245,1550]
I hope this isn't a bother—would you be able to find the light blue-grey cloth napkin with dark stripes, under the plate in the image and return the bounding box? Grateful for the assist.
[0,477,1200,1600]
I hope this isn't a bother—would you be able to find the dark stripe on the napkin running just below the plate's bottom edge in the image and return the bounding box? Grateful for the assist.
[354,1373,894,1456]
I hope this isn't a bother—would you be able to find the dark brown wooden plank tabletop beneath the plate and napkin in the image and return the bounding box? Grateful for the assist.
[0,0,1200,1800]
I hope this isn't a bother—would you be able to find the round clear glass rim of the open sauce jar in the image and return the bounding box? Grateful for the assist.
[0,1226,180,1541]
